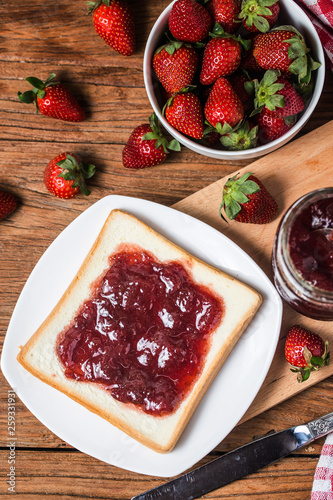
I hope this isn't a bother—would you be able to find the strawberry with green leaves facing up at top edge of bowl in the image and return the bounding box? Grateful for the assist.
[238,0,280,33]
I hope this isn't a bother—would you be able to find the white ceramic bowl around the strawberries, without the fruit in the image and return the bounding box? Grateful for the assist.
[143,0,325,160]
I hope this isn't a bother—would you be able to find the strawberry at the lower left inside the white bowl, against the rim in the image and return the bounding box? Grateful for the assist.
[164,88,205,139]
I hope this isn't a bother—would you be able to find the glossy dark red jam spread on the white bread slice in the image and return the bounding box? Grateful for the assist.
[57,249,223,416]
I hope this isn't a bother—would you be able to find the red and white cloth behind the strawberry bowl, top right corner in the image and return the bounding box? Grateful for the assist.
[297,0,333,71]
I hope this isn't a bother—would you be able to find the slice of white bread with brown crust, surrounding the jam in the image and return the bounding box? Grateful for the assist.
[17,210,262,453]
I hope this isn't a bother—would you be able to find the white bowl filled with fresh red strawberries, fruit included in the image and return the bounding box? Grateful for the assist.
[143,0,325,160]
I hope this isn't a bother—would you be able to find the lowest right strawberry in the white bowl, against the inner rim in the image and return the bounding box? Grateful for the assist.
[255,108,296,144]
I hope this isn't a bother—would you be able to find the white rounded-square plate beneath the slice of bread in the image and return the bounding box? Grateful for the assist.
[1,196,282,477]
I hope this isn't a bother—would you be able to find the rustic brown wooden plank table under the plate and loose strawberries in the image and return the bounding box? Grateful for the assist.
[0,0,333,500]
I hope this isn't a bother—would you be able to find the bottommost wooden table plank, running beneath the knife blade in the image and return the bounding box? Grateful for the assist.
[0,450,318,500]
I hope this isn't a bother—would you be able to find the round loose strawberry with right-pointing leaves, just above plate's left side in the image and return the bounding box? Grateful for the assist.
[44,153,95,198]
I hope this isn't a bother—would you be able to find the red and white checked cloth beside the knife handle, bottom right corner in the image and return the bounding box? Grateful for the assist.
[311,434,333,500]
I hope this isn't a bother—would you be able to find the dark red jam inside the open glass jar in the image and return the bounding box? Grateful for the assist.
[289,198,333,291]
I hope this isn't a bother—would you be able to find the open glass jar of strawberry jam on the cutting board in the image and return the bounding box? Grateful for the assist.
[272,187,333,321]
